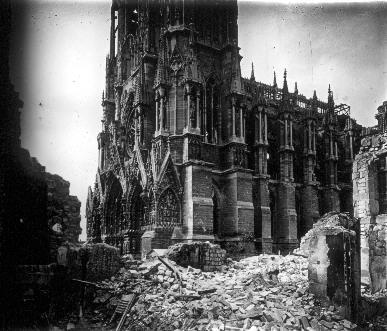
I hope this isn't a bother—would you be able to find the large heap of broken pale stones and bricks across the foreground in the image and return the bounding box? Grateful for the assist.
[87,255,356,330]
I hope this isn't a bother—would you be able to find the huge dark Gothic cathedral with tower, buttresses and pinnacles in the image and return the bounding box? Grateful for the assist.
[86,0,362,256]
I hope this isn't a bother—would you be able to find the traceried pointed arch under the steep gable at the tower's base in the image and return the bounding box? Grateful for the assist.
[157,188,181,227]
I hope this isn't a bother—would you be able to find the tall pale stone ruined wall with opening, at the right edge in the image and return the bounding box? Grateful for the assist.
[352,133,387,291]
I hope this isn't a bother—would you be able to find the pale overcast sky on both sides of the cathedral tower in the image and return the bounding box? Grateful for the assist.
[11,0,387,238]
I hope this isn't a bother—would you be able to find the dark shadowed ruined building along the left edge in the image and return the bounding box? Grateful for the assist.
[0,0,81,324]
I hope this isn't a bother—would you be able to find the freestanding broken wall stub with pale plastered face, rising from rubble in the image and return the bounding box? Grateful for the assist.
[300,212,360,319]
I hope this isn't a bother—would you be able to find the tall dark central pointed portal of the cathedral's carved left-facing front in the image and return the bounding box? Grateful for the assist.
[104,176,123,245]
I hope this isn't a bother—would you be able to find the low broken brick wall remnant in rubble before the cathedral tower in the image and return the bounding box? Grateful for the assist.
[166,242,226,271]
